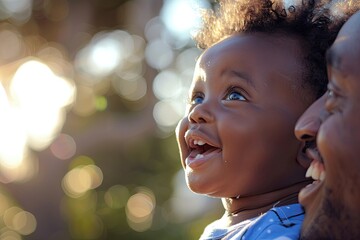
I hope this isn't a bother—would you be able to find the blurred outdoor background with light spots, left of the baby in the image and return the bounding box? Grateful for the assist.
[0,0,222,240]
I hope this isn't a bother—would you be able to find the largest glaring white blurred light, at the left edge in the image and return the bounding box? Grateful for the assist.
[0,58,75,182]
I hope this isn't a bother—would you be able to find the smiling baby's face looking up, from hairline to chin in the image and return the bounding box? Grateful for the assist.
[176,34,309,197]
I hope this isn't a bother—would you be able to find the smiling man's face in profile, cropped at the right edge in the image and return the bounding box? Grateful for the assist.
[295,13,360,239]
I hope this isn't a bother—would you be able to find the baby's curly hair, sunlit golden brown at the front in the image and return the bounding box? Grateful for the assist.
[194,0,344,97]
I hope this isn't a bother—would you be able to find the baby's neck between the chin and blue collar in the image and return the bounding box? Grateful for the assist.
[222,181,310,226]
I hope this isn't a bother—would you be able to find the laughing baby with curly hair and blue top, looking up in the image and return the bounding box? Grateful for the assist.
[176,0,338,240]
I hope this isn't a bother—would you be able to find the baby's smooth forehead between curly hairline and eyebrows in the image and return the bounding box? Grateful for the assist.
[196,34,305,74]
